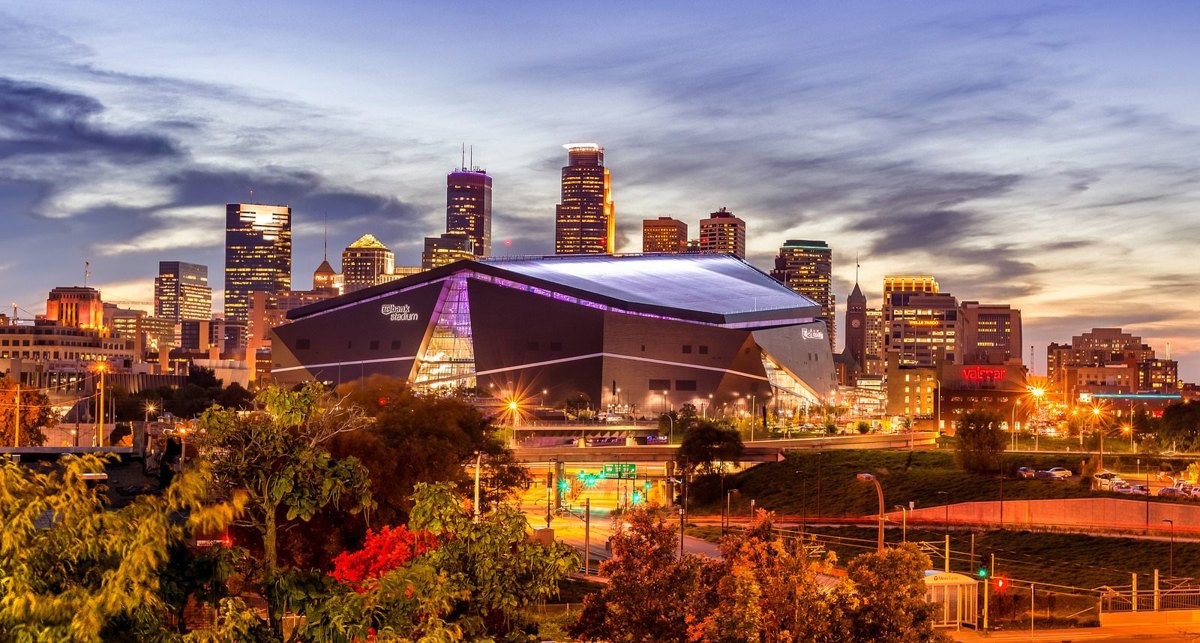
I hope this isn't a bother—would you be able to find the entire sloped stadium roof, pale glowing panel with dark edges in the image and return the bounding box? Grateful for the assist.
[288,254,821,324]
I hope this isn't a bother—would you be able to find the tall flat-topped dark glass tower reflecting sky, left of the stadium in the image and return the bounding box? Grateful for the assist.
[224,203,292,325]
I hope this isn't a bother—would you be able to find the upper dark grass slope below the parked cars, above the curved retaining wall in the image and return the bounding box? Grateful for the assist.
[689,450,1188,517]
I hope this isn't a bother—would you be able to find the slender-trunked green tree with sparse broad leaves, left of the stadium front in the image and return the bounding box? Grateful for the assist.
[197,384,372,637]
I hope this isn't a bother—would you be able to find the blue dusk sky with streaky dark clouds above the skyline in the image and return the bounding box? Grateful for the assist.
[0,0,1200,380]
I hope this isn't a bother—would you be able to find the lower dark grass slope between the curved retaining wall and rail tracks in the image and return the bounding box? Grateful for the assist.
[688,525,1200,589]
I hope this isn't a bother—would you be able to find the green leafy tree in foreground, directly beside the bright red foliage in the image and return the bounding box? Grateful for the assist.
[304,483,578,641]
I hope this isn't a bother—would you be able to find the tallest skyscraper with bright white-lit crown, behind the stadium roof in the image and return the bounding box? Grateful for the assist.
[554,143,617,254]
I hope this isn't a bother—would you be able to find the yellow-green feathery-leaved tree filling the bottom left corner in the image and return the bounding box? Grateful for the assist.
[0,455,239,641]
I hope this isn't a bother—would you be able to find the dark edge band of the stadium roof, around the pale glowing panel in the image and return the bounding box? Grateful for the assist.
[287,253,821,324]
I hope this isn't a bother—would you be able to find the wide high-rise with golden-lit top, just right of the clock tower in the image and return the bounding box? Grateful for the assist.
[883,276,962,368]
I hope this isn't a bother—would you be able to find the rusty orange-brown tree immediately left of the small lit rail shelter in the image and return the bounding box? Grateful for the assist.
[846,542,948,643]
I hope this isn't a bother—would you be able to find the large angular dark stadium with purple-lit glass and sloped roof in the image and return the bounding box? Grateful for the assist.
[271,254,835,415]
